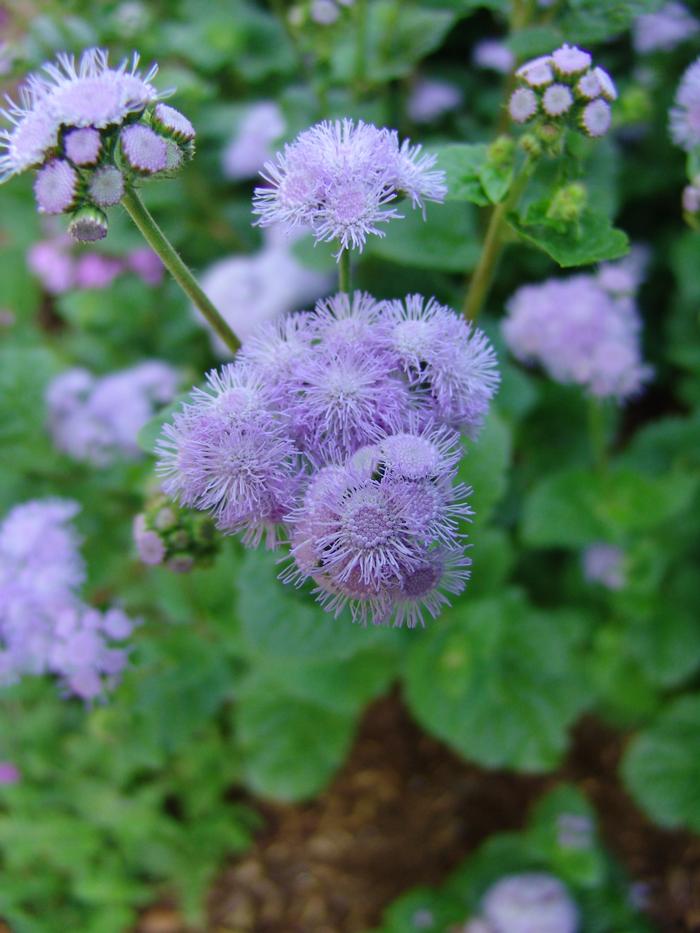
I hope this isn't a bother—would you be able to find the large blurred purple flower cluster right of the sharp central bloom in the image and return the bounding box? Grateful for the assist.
[502,259,651,399]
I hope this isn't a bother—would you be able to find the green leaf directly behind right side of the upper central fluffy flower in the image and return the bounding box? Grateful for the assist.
[367,203,479,272]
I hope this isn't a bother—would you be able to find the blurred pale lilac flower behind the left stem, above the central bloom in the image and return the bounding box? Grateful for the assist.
[194,228,331,357]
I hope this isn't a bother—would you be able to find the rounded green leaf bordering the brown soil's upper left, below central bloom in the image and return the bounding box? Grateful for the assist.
[234,690,355,802]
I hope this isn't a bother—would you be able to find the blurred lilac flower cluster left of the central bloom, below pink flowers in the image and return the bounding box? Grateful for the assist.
[46,360,179,466]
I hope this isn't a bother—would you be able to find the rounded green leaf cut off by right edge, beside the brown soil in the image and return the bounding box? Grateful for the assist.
[622,694,700,832]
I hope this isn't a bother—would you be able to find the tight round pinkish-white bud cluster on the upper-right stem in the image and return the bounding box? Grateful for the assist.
[508,45,617,137]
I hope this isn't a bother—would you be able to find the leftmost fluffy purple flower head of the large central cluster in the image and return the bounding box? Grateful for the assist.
[157,365,300,547]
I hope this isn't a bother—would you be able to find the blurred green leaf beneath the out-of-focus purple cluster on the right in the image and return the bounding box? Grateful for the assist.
[522,467,700,547]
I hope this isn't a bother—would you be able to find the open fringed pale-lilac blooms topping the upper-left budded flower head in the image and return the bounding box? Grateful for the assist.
[0,49,159,181]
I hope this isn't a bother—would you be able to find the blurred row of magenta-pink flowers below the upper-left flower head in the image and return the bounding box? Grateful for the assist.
[27,235,164,295]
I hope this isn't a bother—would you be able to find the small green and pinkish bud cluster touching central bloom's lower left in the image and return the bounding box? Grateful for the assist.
[133,494,220,573]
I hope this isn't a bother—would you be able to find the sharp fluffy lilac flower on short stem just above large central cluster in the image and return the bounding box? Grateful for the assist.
[253,120,447,256]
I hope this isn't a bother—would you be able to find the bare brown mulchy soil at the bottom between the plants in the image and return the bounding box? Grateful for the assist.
[140,696,700,933]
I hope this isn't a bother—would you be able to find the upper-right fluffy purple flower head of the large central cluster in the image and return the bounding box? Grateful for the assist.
[387,295,500,434]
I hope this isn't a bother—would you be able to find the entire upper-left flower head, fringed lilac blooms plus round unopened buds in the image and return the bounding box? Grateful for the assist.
[0,49,195,242]
